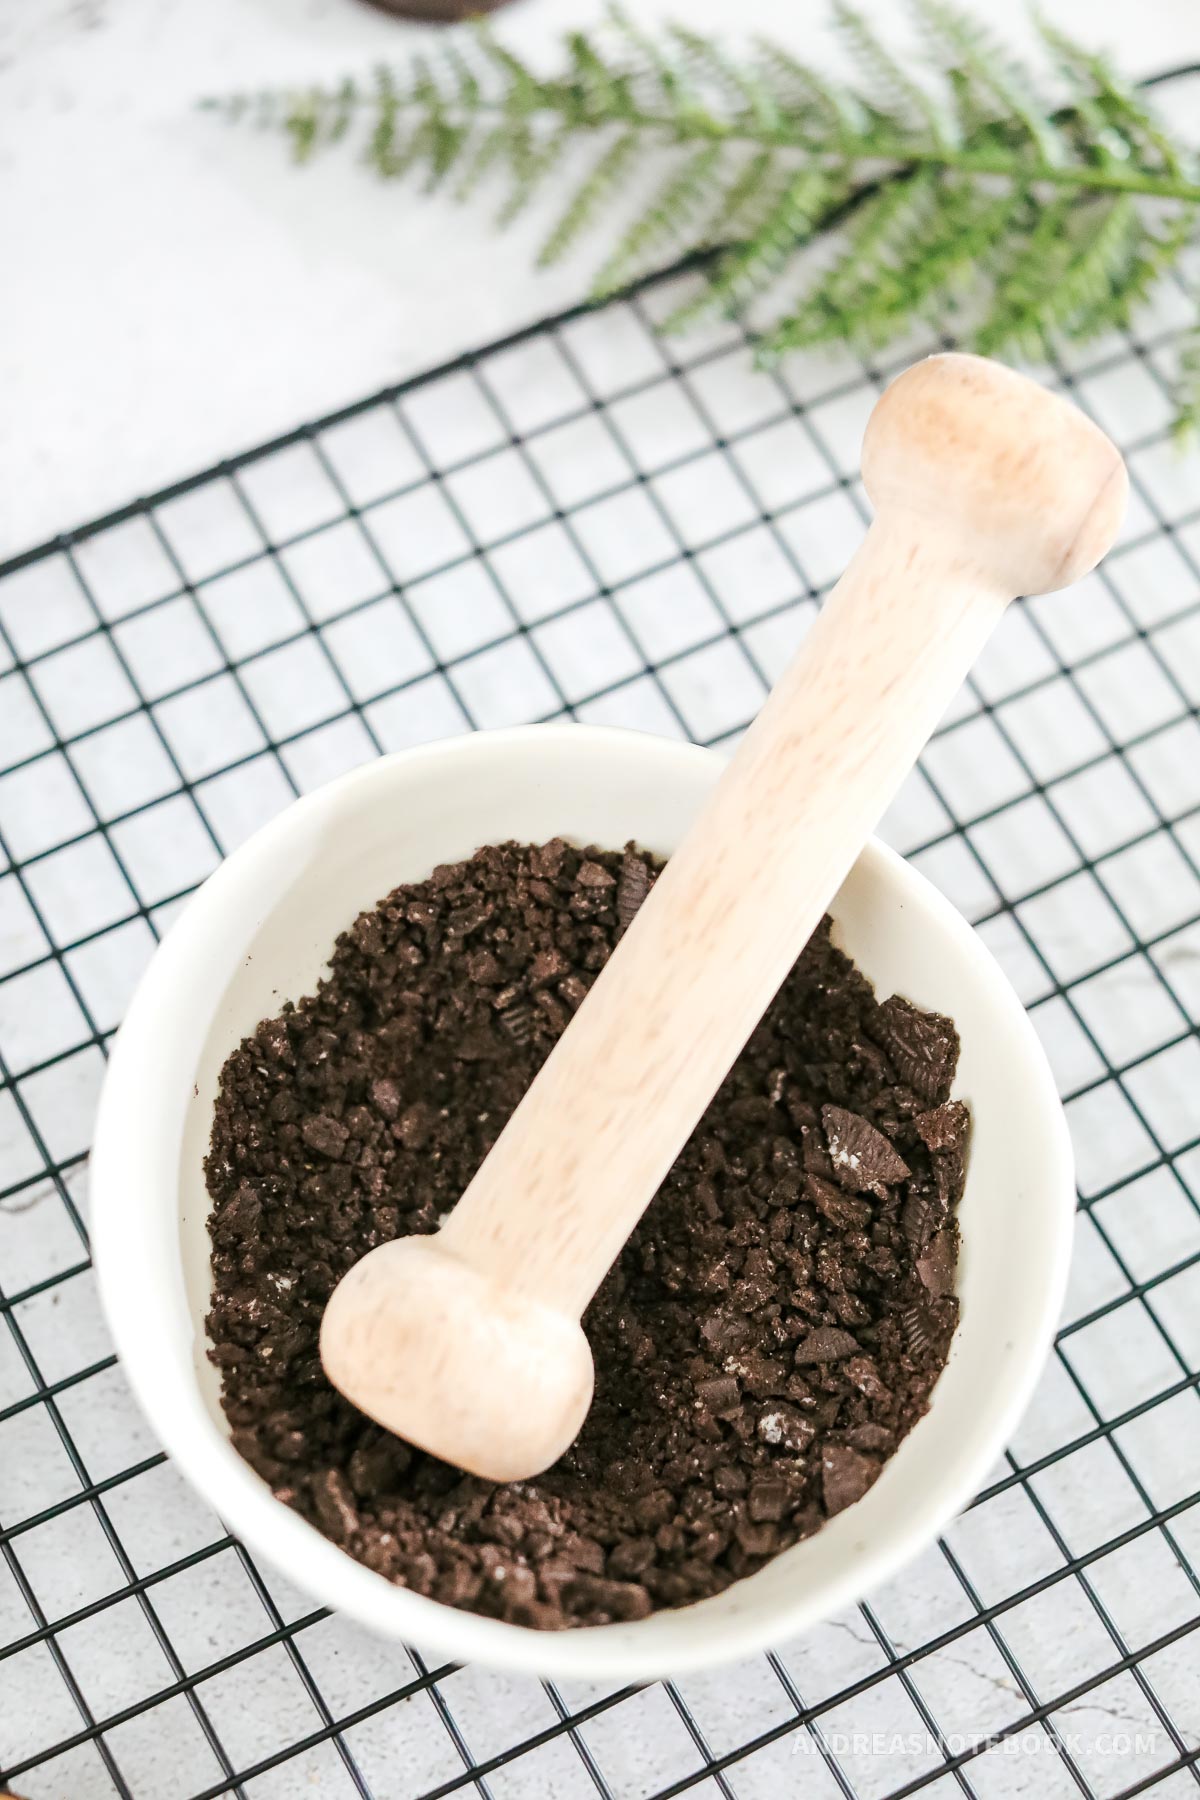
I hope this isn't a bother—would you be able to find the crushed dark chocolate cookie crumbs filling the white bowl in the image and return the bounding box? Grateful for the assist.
[205,839,970,1627]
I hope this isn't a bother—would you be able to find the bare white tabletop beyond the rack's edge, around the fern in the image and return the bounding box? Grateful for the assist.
[0,0,1200,556]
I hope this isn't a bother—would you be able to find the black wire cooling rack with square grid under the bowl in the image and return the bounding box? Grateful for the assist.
[0,239,1200,1800]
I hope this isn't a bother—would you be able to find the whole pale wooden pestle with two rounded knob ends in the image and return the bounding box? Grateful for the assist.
[320,355,1126,1481]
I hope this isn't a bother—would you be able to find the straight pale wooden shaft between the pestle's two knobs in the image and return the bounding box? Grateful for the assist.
[443,515,1013,1318]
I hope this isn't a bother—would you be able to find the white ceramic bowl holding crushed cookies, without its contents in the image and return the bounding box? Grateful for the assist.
[94,727,1072,1679]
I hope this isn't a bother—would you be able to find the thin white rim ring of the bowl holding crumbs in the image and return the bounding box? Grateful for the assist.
[90,724,1074,1681]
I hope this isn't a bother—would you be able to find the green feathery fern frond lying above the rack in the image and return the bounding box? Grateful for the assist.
[201,0,1200,430]
